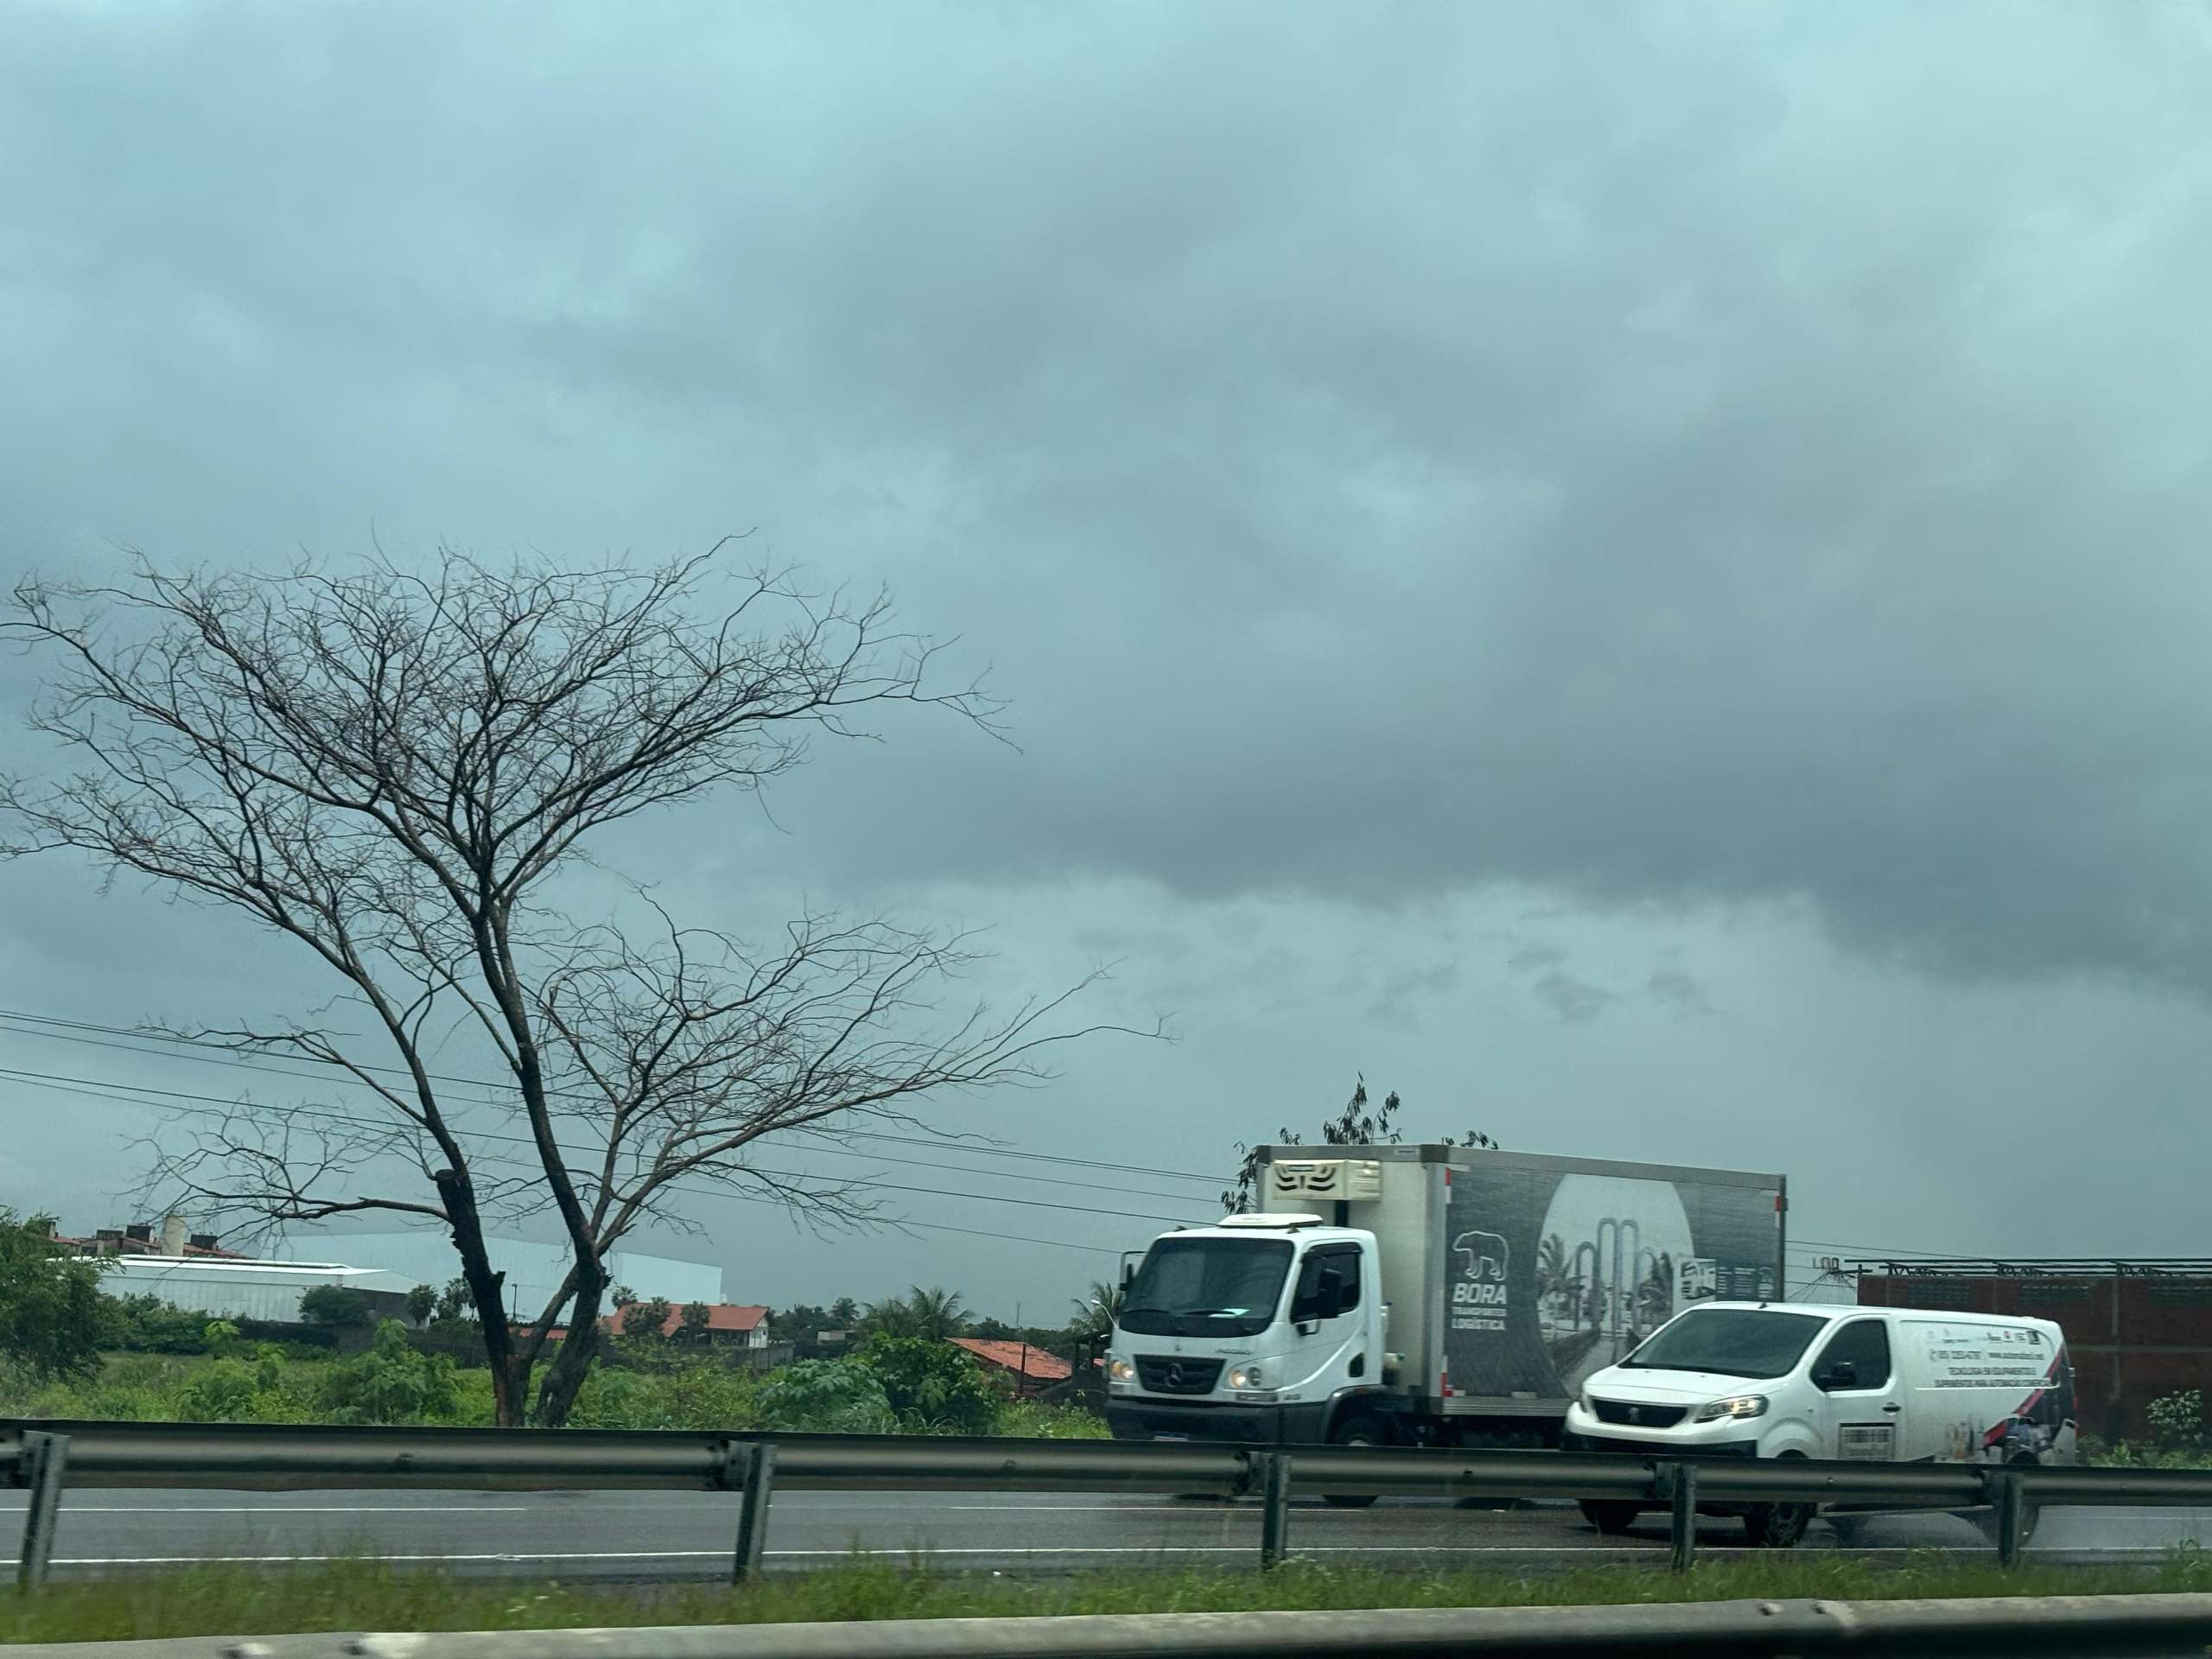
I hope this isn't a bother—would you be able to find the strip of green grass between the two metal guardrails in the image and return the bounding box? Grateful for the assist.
[0,1551,2212,1642]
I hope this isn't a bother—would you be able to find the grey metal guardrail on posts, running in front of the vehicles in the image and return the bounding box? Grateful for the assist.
[13,1421,2212,1584]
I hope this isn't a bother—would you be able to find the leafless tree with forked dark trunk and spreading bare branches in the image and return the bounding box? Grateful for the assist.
[0,546,1141,1425]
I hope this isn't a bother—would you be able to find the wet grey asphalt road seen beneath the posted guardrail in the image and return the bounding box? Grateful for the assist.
[7,1491,2212,1580]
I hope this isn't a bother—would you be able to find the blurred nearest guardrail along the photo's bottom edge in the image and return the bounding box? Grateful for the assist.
[13,1595,2212,1659]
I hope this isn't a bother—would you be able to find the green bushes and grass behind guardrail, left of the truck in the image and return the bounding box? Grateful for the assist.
[0,1210,1109,1438]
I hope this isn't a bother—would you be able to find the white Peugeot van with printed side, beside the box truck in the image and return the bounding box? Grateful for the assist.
[1566,1303,2075,1548]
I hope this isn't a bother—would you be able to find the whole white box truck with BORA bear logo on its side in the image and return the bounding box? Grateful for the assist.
[1106,1146,1787,1446]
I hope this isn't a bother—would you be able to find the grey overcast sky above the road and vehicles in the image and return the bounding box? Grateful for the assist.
[0,0,2212,1319]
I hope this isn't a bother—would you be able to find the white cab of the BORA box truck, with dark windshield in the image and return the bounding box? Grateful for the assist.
[1106,1214,1385,1445]
